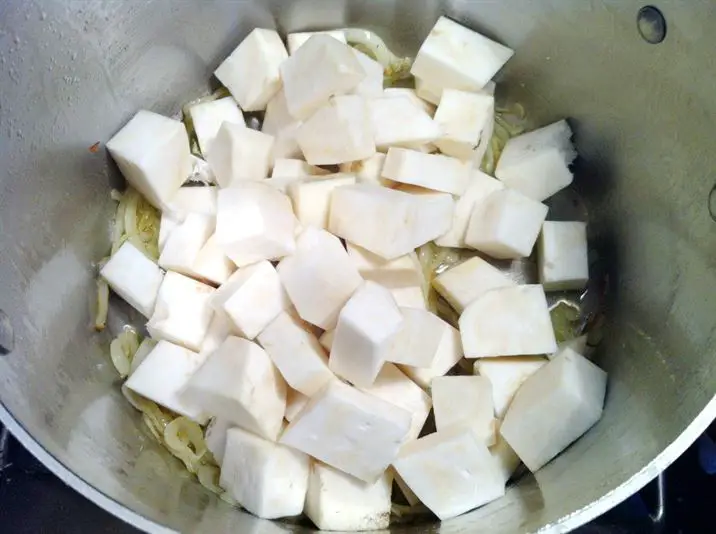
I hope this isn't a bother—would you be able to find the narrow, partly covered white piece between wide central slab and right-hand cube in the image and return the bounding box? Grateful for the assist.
[435,169,504,248]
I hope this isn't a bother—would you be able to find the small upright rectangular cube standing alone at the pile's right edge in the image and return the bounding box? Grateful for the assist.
[538,221,589,291]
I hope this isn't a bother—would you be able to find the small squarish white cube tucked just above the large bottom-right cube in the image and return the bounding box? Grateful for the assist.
[431,376,495,447]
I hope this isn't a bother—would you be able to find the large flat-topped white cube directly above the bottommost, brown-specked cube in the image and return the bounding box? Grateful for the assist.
[281,380,412,483]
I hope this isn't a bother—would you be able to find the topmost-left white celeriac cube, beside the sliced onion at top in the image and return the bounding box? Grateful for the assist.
[214,28,288,111]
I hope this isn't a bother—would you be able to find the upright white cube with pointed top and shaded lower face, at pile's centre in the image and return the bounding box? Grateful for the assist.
[328,282,403,388]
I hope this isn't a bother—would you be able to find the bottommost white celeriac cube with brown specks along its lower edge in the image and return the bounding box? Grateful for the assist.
[304,462,393,532]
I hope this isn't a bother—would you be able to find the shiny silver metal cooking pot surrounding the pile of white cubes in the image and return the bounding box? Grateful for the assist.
[0,0,716,534]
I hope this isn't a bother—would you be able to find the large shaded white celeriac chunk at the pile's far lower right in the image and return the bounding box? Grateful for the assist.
[500,350,607,472]
